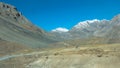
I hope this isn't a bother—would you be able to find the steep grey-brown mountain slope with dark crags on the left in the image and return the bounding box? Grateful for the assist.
[0,3,54,51]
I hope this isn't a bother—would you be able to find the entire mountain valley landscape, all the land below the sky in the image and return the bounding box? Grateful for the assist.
[0,2,120,68]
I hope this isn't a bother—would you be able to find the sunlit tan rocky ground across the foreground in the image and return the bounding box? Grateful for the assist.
[0,44,120,68]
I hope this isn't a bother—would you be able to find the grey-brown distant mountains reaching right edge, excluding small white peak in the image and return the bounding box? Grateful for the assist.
[51,14,120,42]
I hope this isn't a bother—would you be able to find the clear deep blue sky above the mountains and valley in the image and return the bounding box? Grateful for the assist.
[0,0,120,31]
